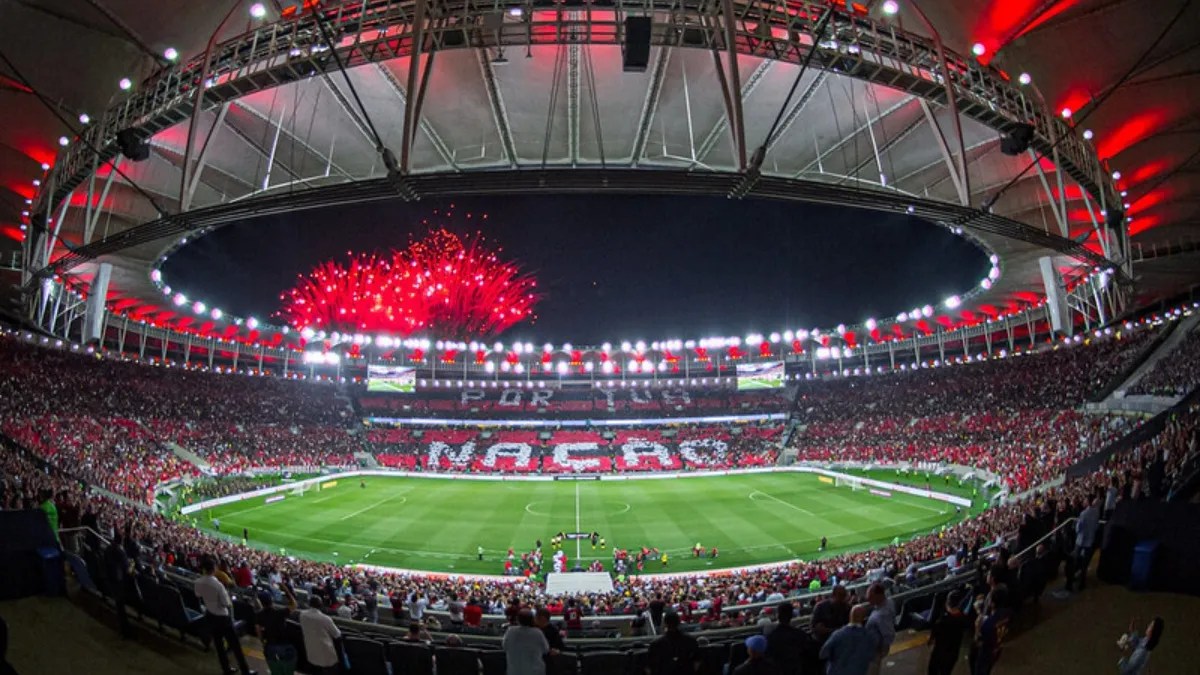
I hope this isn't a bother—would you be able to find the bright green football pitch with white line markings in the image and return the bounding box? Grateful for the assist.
[199,473,971,574]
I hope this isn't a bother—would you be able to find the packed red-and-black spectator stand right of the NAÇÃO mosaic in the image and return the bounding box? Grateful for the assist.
[791,331,1150,492]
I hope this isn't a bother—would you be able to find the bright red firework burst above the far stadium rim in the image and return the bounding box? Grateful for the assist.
[280,229,539,339]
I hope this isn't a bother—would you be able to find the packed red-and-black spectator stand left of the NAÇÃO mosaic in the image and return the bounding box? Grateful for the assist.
[0,338,353,503]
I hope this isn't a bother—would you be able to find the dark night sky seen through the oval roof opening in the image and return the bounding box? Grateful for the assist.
[163,196,989,345]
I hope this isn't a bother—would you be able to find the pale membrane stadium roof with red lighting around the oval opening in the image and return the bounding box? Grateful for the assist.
[0,0,1200,338]
